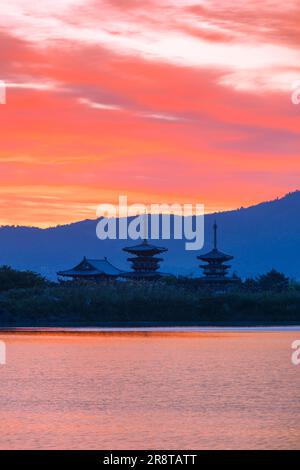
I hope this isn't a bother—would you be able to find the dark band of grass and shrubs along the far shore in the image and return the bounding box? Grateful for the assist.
[0,282,300,326]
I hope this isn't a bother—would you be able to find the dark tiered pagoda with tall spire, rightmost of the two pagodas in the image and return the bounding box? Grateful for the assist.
[197,222,236,289]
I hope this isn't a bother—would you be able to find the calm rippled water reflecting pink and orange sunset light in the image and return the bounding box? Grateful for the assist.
[0,329,300,449]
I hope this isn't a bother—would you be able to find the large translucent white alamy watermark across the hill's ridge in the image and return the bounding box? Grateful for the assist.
[96,196,204,250]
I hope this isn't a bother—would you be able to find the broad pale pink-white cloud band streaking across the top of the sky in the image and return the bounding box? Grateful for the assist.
[0,0,300,92]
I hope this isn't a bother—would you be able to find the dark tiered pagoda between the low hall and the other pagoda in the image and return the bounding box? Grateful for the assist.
[123,239,168,280]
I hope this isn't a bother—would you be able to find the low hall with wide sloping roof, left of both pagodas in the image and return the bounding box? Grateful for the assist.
[57,257,123,277]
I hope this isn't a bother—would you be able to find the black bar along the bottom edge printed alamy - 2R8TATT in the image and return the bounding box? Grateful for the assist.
[0,450,299,464]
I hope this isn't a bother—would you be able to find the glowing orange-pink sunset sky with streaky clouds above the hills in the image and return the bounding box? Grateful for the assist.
[0,0,300,227]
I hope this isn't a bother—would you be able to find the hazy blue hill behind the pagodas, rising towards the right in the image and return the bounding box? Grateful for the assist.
[0,191,300,279]
